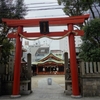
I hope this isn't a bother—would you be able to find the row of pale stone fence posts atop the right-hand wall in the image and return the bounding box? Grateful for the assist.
[80,62,100,75]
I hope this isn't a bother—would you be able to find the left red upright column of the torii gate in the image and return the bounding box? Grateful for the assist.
[11,26,23,97]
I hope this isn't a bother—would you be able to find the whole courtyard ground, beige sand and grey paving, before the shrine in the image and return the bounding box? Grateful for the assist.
[0,75,100,100]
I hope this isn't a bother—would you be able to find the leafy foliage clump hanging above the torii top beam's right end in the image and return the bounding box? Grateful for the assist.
[58,0,93,16]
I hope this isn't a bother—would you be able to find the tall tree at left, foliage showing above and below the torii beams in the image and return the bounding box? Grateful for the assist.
[0,0,27,64]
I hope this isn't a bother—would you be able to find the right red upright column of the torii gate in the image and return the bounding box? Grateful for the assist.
[68,24,80,97]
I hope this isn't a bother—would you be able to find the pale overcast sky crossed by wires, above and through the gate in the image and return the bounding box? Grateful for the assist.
[24,0,66,49]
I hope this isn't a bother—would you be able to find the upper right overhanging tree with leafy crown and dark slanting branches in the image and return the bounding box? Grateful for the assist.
[58,0,100,18]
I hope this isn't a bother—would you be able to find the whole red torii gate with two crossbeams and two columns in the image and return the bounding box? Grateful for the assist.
[2,15,89,97]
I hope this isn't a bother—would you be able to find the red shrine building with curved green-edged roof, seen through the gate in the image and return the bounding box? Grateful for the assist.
[32,53,64,75]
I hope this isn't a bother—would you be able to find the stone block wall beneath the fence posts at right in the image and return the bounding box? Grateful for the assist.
[80,77,100,97]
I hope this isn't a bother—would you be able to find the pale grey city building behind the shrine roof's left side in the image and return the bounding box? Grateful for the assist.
[23,41,49,62]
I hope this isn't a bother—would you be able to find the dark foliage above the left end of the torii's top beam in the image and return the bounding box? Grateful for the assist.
[0,0,27,22]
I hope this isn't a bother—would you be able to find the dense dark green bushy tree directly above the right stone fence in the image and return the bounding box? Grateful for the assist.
[79,19,100,61]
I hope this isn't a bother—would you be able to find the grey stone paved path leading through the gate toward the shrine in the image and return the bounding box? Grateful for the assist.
[0,77,100,100]
